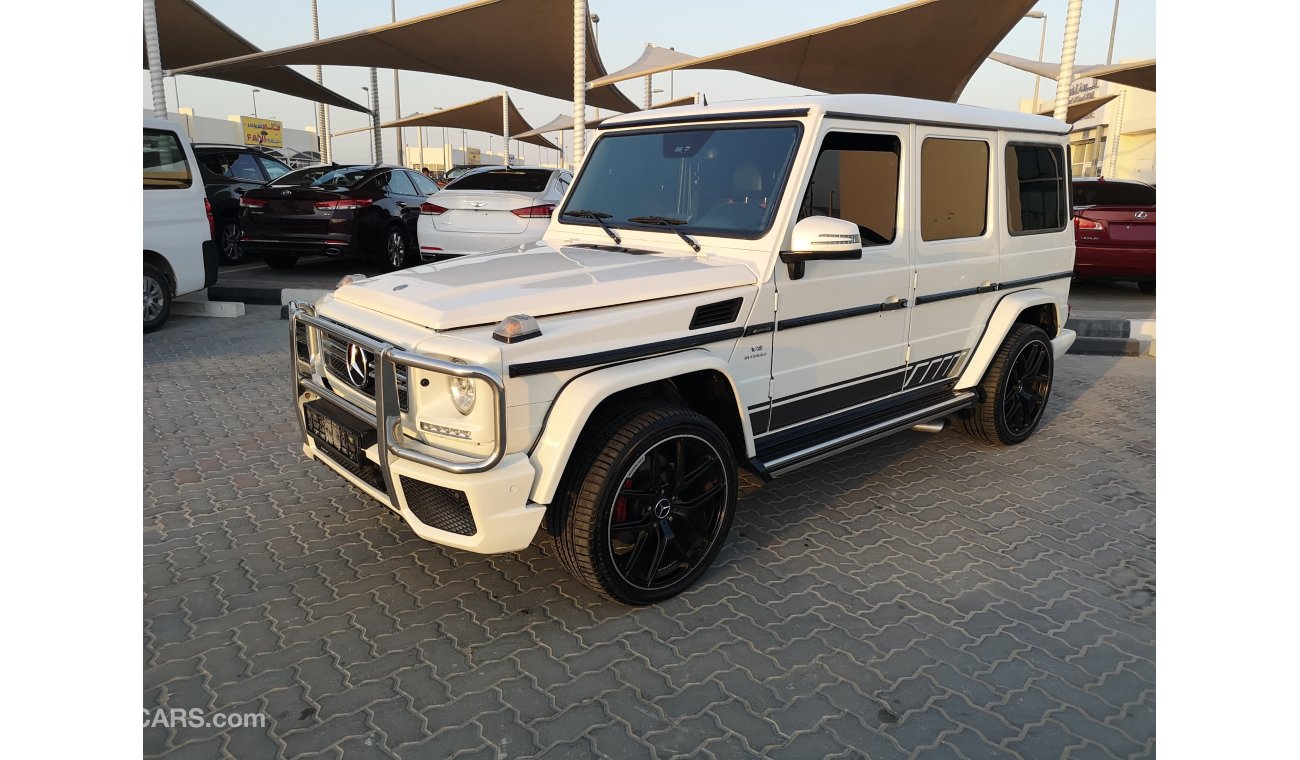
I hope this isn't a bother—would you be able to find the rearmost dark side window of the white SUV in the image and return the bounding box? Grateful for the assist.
[1006,144,1067,235]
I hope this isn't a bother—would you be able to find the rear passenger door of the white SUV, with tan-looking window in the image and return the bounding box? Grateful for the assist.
[904,126,1000,390]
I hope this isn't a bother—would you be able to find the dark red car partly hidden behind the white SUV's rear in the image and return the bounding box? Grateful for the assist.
[1073,178,1156,294]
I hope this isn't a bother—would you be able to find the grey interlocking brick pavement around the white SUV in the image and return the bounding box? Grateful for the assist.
[143,309,1156,760]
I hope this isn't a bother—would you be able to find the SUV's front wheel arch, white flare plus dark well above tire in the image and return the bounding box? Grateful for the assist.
[529,349,754,504]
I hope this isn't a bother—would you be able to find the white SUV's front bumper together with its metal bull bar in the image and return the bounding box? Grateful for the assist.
[289,303,546,553]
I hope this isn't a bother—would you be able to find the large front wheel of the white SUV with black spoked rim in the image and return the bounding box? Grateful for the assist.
[551,405,737,605]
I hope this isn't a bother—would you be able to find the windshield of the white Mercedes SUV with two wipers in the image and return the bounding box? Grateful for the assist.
[562,125,800,239]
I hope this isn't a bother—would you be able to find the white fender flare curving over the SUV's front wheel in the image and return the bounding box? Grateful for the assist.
[528,349,754,504]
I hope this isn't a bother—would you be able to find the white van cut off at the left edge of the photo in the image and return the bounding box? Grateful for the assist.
[144,118,217,331]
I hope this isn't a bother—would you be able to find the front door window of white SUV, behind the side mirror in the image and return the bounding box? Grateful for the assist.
[800,133,900,246]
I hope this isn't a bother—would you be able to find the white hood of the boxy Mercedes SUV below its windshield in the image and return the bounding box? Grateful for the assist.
[334,242,757,330]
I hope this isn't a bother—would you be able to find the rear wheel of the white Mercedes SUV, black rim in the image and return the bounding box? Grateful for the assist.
[962,323,1054,446]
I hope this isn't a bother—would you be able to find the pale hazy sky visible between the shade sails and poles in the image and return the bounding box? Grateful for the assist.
[140,0,1156,162]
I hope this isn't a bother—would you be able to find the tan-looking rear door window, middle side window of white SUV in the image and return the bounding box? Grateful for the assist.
[920,138,988,240]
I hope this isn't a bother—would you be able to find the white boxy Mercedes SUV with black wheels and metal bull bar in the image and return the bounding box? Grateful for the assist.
[290,95,1074,604]
